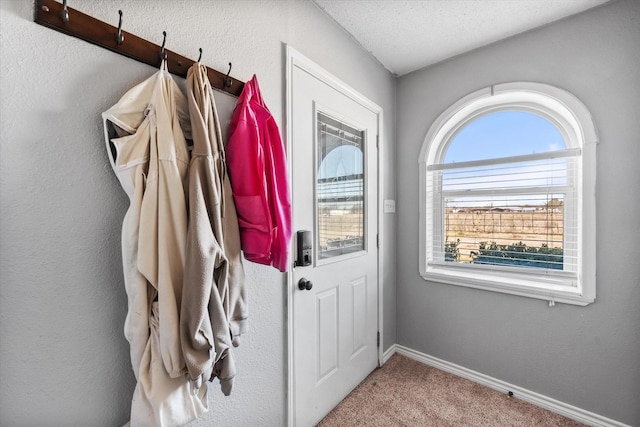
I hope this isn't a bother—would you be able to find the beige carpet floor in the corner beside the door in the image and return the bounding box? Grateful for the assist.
[318,354,582,427]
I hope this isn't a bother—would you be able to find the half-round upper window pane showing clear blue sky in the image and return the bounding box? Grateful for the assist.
[442,110,567,163]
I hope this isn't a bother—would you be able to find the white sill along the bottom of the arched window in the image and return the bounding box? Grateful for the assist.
[420,264,595,306]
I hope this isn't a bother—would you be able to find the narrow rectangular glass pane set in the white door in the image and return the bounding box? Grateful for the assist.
[316,112,365,260]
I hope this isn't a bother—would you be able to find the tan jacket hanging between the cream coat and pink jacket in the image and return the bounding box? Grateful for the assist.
[180,63,247,395]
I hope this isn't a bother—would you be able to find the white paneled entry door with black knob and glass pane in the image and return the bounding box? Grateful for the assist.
[289,51,379,427]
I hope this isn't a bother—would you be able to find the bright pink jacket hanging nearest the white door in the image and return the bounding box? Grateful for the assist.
[226,75,291,272]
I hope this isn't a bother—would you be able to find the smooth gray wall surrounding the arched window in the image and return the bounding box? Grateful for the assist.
[397,0,640,425]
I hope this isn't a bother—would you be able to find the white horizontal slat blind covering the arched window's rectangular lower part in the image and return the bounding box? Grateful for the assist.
[427,149,580,272]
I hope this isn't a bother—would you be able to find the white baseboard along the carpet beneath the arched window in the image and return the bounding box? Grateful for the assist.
[382,344,629,427]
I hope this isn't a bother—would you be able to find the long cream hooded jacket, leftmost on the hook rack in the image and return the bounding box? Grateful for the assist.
[102,64,207,427]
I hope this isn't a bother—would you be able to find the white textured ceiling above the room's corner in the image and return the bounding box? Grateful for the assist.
[313,0,609,75]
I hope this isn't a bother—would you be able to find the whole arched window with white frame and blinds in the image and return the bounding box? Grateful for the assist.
[419,83,597,305]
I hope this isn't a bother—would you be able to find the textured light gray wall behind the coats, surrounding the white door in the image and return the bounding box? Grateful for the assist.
[0,0,396,426]
